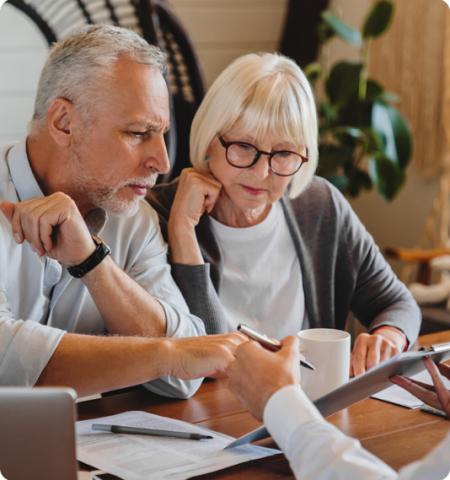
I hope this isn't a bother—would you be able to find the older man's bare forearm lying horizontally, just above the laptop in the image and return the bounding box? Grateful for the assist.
[36,333,170,396]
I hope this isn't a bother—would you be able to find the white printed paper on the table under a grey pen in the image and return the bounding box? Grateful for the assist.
[76,411,281,480]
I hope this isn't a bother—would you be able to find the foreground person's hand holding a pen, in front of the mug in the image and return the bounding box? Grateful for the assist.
[226,337,300,419]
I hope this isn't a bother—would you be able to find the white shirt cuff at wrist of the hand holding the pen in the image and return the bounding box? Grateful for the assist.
[263,385,324,451]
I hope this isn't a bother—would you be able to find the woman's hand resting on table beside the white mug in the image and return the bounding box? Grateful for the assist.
[350,327,406,376]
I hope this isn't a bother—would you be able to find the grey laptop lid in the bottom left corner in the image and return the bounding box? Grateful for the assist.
[0,387,77,480]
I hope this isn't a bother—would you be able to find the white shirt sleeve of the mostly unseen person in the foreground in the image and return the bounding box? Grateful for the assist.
[264,385,398,480]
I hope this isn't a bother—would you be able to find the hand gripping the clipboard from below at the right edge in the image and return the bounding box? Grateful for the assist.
[391,358,450,417]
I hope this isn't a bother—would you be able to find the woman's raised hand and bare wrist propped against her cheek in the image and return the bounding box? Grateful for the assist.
[168,168,222,265]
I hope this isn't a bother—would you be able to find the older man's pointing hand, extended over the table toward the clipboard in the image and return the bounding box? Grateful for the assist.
[164,333,248,380]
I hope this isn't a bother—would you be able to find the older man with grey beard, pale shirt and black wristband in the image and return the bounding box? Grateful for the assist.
[0,26,241,396]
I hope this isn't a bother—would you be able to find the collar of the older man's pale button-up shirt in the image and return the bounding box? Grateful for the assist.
[6,140,108,235]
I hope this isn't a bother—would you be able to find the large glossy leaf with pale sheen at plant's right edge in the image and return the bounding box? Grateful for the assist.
[372,102,412,168]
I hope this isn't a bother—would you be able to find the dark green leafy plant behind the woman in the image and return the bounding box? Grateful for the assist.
[305,0,412,200]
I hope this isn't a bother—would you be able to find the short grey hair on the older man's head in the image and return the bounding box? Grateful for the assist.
[30,25,166,131]
